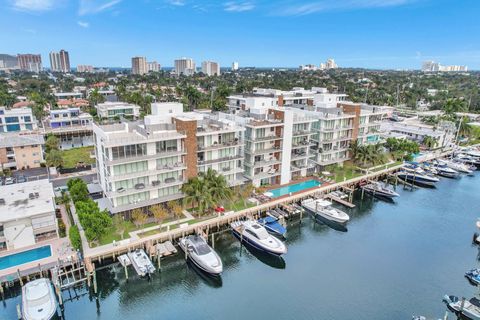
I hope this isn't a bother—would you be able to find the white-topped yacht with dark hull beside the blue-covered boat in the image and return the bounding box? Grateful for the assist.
[230,220,287,256]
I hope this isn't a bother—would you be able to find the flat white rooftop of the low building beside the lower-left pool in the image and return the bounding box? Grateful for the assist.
[0,179,55,223]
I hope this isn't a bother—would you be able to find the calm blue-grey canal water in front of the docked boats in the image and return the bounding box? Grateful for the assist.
[0,173,480,320]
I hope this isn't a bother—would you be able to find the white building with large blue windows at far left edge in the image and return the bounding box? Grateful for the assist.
[0,107,38,133]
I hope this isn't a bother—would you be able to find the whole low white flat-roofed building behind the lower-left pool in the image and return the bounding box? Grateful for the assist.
[0,179,58,250]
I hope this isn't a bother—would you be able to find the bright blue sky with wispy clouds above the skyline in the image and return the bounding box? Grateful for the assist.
[0,0,480,70]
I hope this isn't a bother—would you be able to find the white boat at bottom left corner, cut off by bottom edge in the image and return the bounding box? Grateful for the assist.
[22,278,57,320]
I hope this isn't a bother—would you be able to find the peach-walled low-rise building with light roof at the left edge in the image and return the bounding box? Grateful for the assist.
[0,133,45,170]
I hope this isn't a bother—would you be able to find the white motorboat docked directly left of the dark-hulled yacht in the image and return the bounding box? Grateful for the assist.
[178,235,223,275]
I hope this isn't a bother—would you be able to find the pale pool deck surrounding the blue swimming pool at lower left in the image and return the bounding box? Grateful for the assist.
[0,238,76,282]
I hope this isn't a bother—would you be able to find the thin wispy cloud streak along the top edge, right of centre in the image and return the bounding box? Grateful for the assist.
[276,0,418,16]
